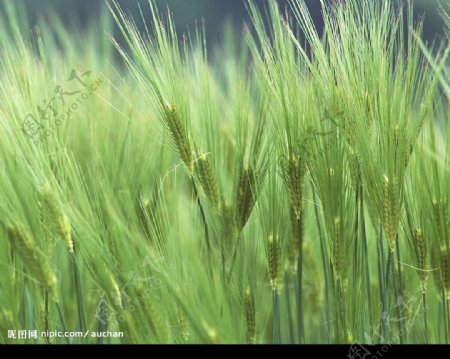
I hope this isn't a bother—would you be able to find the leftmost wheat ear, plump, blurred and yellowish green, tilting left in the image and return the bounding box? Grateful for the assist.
[6,222,57,299]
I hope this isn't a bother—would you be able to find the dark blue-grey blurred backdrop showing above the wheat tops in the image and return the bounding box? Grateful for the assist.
[0,0,450,44]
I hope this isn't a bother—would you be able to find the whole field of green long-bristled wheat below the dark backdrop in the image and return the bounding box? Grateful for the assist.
[0,0,450,344]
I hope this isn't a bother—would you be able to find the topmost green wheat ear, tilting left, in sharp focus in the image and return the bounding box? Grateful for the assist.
[164,105,194,176]
